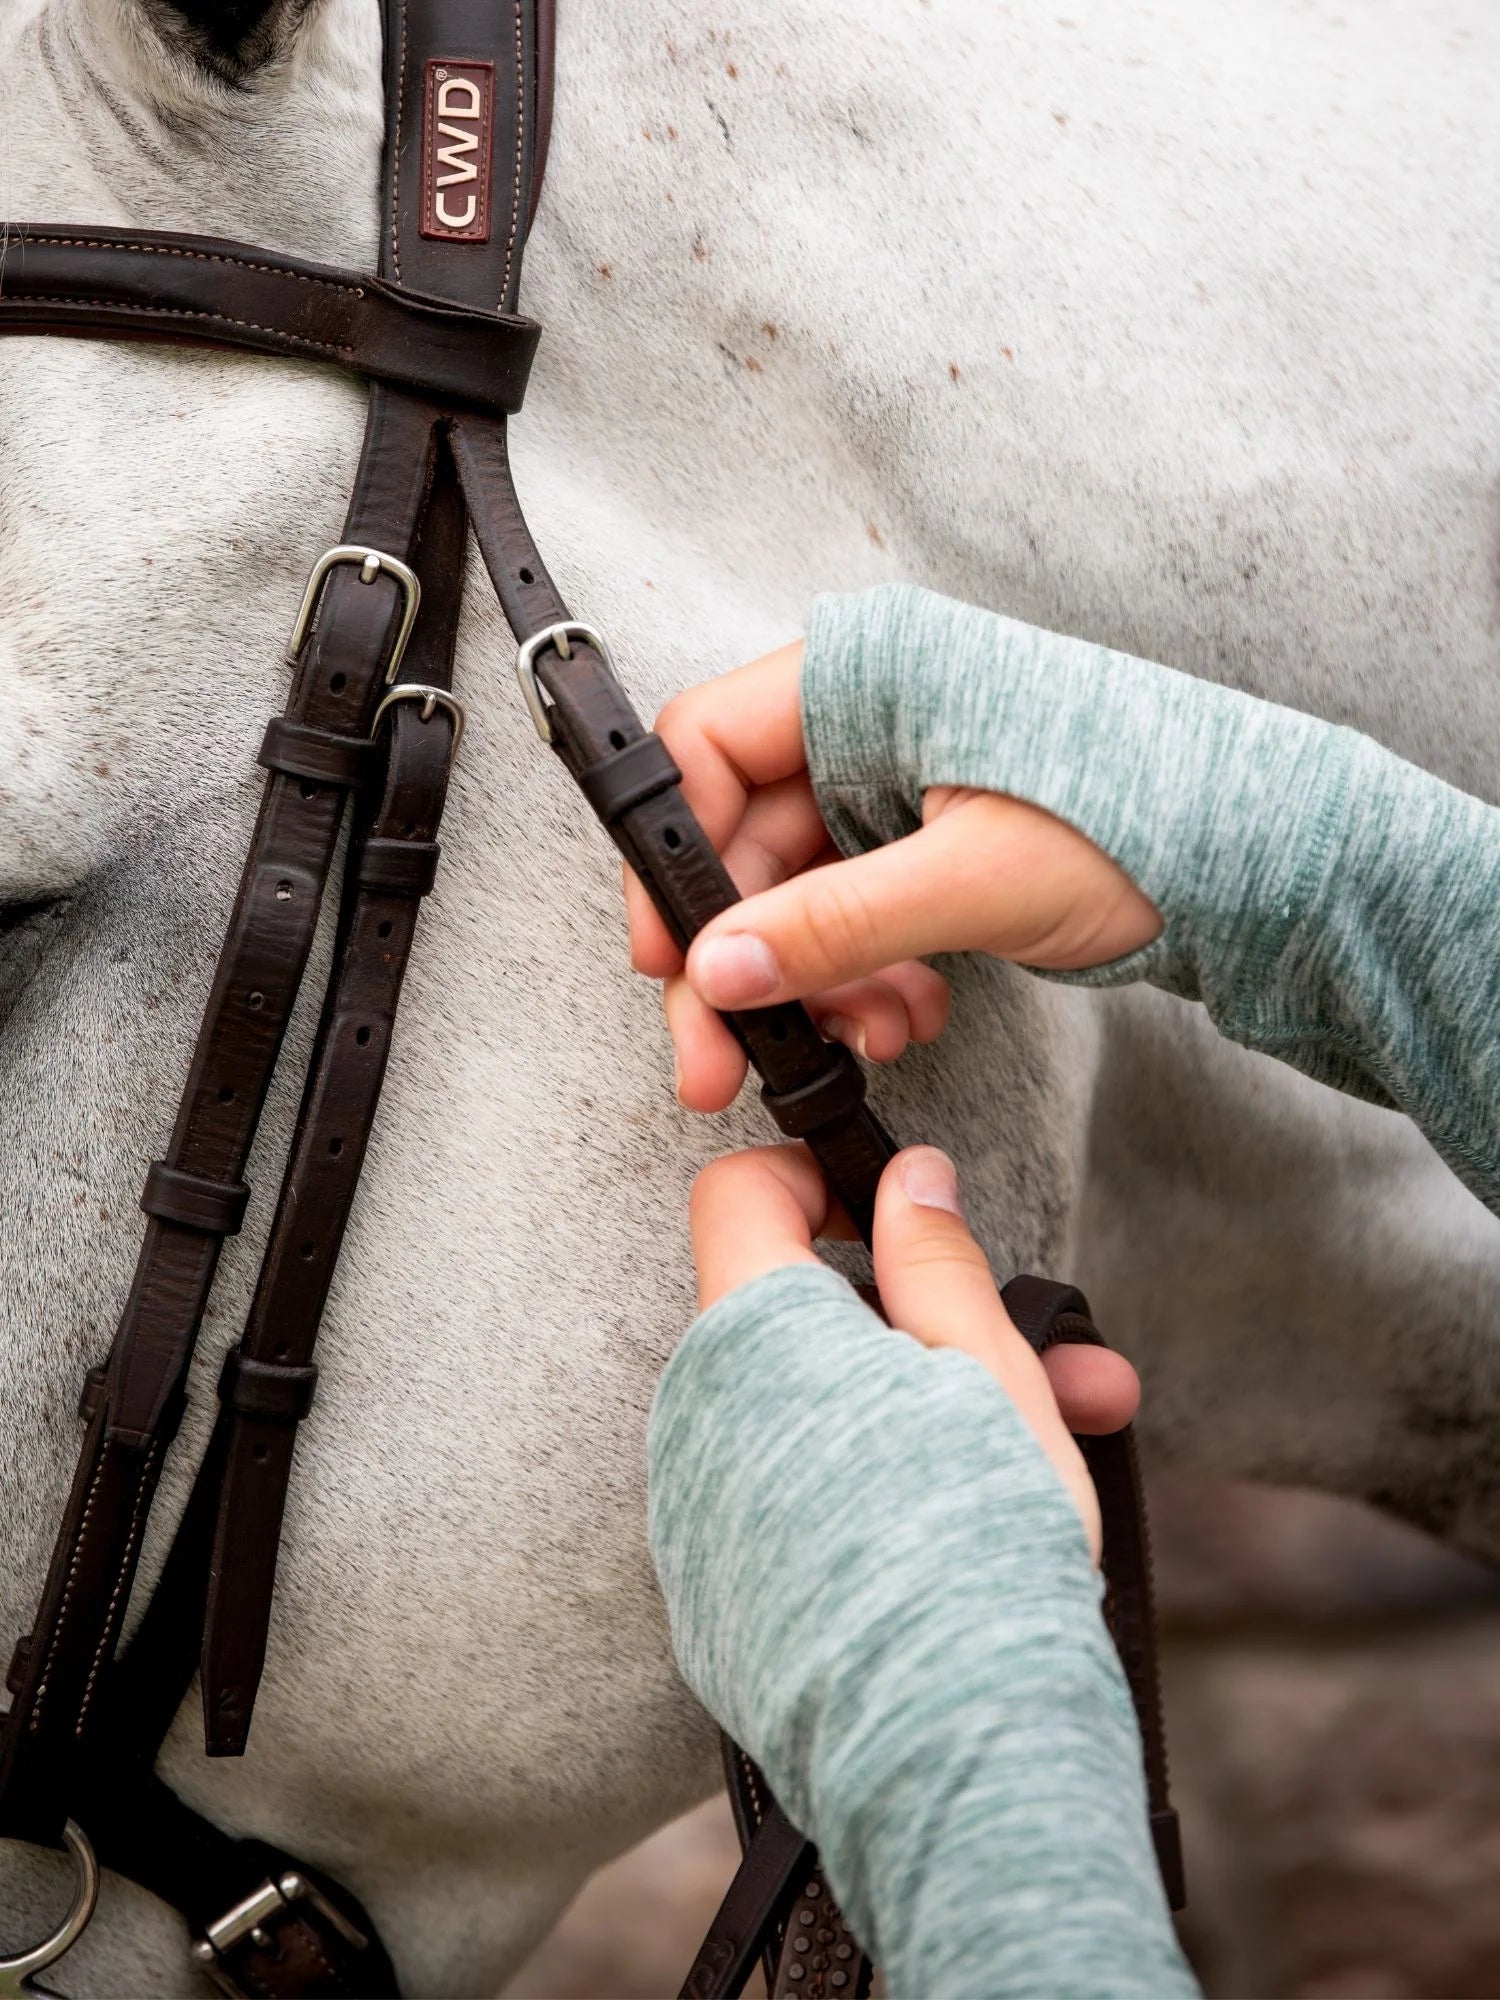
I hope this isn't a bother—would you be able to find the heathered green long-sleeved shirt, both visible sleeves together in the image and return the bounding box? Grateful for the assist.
[650,588,1500,2000]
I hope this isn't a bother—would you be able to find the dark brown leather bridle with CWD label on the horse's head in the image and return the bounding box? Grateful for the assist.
[0,0,1182,2000]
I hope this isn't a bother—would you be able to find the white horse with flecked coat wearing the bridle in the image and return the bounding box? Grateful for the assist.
[0,0,1500,1994]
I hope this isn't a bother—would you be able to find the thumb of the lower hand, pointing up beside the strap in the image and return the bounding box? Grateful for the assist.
[874,1146,1100,1562]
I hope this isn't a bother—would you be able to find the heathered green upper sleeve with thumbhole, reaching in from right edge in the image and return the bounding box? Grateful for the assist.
[802,584,1500,1212]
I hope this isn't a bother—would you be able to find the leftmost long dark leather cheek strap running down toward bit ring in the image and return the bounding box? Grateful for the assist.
[0,386,446,1840]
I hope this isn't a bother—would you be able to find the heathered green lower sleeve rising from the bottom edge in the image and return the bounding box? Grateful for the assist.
[650,1264,1196,2000]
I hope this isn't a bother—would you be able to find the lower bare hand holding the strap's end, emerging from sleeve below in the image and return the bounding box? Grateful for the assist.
[692,1146,1140,1562]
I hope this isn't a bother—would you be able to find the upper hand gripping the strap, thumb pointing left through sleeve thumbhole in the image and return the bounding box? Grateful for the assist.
[626,644,1162,1112]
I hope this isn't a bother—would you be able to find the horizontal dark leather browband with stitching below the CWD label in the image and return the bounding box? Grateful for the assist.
[0,222,540,410]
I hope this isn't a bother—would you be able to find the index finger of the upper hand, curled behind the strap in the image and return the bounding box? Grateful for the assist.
[624,640,806,978]
